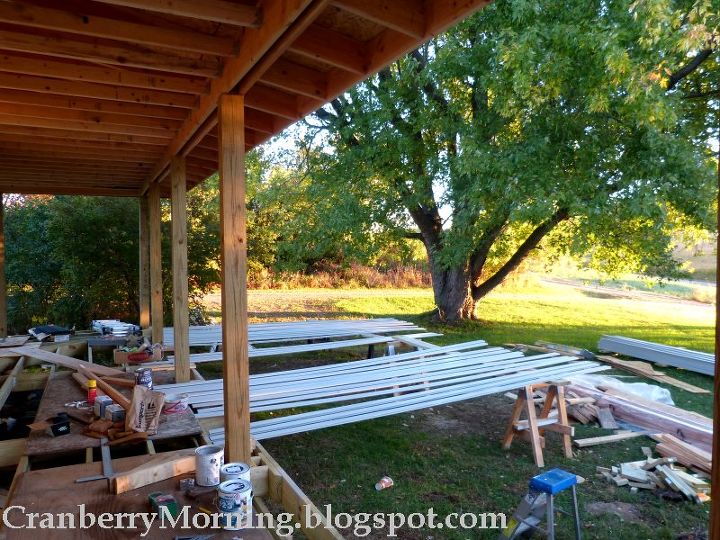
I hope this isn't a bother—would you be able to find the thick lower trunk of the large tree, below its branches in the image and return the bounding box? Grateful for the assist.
[431,264,475,323]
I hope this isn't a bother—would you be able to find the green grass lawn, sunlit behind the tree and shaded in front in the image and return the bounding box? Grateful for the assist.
[208,284,713,540]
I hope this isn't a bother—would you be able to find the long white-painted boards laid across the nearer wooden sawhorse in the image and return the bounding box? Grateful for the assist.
[157,340,610,444]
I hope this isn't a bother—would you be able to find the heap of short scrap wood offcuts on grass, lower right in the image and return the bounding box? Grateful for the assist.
[597,448,710,503]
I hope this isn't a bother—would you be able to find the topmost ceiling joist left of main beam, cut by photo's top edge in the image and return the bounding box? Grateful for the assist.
[93,0,262,28]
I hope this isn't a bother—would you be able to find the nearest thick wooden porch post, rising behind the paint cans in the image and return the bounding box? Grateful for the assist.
[218,94,252,463]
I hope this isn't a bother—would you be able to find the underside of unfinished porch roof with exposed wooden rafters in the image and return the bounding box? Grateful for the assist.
[0,0,488,196]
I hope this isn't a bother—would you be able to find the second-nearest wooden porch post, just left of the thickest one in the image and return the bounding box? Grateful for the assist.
[170,156,190,382]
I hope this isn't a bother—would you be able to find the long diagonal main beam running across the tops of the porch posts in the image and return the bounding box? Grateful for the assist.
[142,0,313,193]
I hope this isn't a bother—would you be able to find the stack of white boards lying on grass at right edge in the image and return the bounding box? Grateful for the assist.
[598,336,715,376]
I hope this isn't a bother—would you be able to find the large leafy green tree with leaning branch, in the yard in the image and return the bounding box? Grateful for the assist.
[300,0,720,320]
